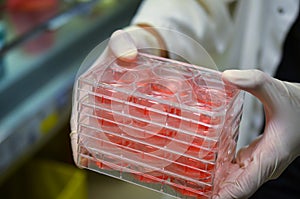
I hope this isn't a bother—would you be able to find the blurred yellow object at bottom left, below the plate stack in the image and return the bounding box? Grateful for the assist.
[30,161,87,199]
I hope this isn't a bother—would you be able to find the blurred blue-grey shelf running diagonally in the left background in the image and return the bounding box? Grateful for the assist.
[0,0,140,183]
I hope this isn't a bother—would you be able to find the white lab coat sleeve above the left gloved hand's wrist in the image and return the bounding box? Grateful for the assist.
[132,0,232,64]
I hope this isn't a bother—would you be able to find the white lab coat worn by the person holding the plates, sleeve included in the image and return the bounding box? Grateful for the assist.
[132,0,299,148]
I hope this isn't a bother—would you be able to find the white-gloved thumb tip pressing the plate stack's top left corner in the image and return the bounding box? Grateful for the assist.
[108,30,138,62]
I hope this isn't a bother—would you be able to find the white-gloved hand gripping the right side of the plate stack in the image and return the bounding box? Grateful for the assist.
[213,70,300,199]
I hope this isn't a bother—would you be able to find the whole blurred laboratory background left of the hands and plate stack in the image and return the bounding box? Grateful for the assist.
[0,0,164,199]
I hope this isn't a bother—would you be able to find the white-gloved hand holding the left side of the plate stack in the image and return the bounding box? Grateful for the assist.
[70,25,166,166]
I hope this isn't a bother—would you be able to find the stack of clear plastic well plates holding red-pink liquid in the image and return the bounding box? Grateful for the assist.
[73,53,243,198]
